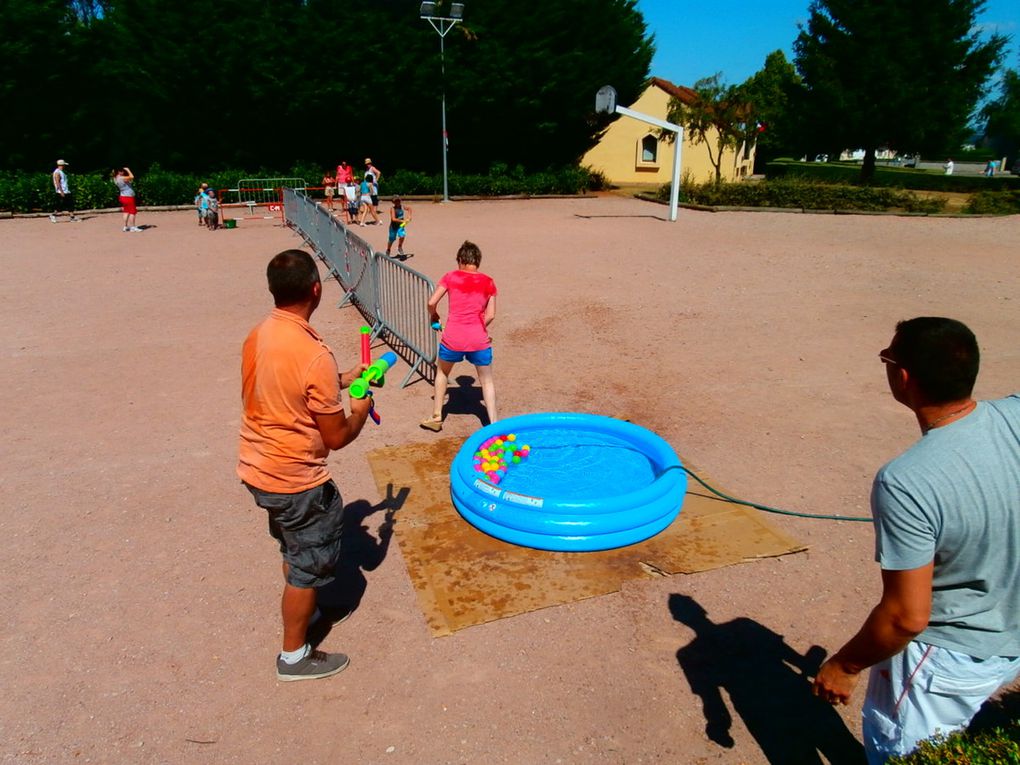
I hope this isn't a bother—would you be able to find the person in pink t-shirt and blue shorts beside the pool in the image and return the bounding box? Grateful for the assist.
[421,242,498,432]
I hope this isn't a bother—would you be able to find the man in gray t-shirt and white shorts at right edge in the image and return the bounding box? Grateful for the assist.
[814,316,1020,765]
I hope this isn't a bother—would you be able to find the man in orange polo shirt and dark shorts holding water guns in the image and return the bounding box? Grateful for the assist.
[238,250,370,680]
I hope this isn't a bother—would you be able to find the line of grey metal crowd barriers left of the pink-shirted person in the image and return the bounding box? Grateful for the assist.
[283,189,439,388]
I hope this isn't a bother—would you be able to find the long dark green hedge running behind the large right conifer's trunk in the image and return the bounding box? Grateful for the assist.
[765,159,1020,194]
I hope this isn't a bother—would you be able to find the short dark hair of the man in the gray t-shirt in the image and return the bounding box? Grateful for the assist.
[889,316,981,404]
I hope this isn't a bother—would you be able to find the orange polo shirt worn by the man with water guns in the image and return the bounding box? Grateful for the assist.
[238,308,344,494]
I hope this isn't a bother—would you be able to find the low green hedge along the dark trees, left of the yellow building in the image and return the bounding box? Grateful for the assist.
[0,165,606,212]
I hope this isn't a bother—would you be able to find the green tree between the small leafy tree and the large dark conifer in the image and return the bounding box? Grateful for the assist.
[741,50,804,169]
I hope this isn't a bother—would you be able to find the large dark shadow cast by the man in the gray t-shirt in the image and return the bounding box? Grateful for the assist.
[669,594,865,765]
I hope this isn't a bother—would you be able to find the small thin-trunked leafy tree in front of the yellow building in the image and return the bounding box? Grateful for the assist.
[660,72,753,183]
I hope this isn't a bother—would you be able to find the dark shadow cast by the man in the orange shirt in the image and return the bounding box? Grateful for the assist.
[308,483,411,646]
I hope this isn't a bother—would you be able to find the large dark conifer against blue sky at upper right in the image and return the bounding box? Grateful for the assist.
[794,0,1006,182]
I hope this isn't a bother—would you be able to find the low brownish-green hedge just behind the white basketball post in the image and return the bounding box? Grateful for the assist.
[658,177,946,213]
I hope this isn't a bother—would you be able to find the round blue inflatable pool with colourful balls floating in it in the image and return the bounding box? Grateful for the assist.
[450,412,687,552]
